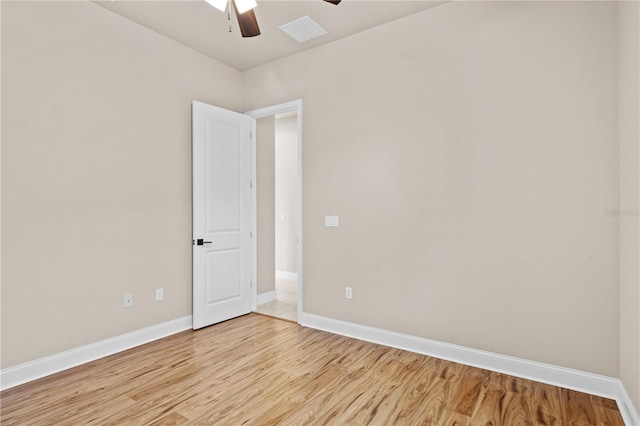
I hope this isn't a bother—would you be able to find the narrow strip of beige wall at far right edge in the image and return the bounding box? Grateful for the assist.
[618,2,640,409]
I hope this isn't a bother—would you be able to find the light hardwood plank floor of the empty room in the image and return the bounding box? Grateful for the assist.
[0,314,623,426]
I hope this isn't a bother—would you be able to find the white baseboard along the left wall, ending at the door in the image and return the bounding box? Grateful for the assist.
[0,315,192,390]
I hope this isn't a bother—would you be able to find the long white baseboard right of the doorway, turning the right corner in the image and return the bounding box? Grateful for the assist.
[298,312,640,426]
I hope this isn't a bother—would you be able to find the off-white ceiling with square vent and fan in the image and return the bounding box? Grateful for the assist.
[95,0,445,71]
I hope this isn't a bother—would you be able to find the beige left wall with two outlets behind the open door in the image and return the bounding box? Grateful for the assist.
[2,2,242,368]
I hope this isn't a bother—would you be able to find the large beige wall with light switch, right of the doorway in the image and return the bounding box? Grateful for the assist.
[243,2,619,376]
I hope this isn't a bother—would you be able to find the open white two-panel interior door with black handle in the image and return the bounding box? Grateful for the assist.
[192,101,253,329]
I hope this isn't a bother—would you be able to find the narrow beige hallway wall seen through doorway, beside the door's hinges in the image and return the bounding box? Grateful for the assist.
[256,115,276,294]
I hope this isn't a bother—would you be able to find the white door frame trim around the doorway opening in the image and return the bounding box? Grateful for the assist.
[245,99,304,323]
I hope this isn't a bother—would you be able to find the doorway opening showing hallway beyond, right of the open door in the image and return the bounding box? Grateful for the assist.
[247,101,302,322]
